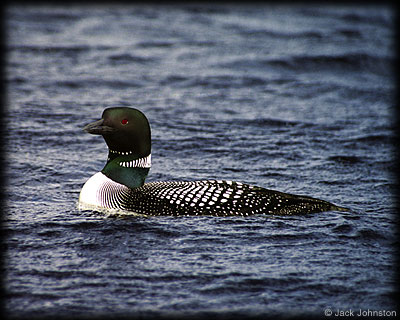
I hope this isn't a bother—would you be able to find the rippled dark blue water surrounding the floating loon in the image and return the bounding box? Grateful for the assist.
[2,5,397,318]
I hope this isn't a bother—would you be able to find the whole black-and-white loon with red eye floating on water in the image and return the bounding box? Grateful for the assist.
[79,107,348,216]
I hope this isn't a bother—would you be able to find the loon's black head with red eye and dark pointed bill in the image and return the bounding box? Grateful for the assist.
[83,107,151,158]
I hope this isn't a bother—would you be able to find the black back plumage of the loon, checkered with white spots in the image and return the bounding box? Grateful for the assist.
[122,180,339,216]
